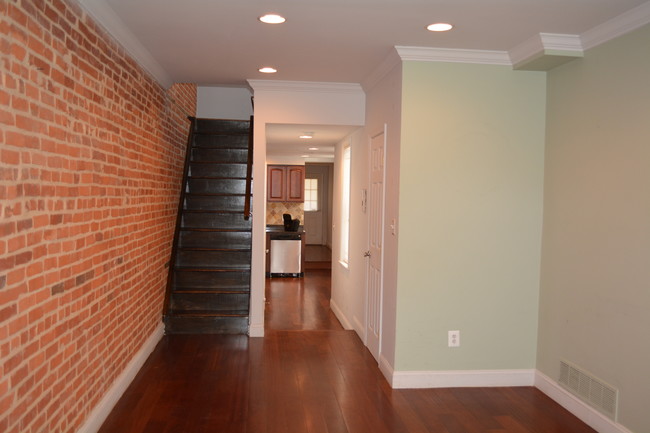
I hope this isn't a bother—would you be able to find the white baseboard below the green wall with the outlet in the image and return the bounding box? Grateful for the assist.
[388,366,535,389]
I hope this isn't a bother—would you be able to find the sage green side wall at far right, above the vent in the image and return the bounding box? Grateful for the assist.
[537,26,650,433]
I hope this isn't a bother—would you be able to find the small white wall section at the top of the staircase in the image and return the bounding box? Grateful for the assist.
[196,86,253,120]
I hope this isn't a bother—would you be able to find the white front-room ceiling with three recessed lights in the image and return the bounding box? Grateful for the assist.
[92,0,646,85]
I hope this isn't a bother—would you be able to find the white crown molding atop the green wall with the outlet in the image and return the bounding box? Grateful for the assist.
[395,46,512,66]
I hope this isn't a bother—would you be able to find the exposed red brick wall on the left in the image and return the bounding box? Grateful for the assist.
[0,0,196,433]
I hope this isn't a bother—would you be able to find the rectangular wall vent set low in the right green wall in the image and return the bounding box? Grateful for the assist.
[559,361,618,421]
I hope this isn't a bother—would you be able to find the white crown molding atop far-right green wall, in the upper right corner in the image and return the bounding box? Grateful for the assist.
[580,1,650,50]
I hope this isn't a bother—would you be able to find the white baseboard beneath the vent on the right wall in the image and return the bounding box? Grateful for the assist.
[535,370,632,433]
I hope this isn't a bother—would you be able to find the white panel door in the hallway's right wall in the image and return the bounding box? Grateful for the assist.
[366,132,386,361]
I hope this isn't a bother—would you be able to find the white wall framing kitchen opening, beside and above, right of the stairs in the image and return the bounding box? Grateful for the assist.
[249,80,365,337]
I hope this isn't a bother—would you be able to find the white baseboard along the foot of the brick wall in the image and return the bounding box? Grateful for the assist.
[77,322,165,433]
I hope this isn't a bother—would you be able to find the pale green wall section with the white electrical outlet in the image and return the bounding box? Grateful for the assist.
[395,61,546,371]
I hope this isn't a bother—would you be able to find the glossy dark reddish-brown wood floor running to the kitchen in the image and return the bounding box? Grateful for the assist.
[100,271,594,433]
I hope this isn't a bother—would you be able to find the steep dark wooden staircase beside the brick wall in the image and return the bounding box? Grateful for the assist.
[164,117,252,334]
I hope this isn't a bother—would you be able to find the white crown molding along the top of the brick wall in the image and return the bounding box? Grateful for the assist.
[78,0,174,89]
